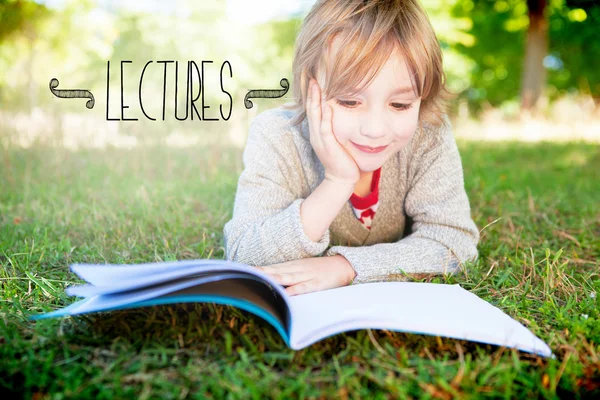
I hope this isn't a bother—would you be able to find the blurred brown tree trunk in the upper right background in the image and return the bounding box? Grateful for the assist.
[521,0,548,111]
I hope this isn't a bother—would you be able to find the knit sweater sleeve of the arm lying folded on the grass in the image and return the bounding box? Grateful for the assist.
[326,116,479,284]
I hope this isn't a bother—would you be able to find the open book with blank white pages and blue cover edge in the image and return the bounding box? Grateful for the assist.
[30,259,554,358]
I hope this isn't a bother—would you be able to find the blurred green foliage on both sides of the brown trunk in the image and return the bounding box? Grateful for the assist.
[450,0,600,113]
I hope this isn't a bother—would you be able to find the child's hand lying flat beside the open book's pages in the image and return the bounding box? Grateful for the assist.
[255,254,356,296]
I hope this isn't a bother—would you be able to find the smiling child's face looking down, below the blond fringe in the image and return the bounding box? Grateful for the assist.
[319,39,421,173]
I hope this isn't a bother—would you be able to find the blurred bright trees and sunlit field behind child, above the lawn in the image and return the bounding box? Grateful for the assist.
[0,0,600,150]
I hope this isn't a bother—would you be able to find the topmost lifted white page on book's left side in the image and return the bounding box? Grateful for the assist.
[70,259,251,286]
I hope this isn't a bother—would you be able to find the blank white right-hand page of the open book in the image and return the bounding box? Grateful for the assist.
[289,282,552,357]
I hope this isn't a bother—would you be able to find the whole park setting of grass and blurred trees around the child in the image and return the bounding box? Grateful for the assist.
[0,0,600,398]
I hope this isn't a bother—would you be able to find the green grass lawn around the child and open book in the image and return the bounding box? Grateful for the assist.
[0,137,600,399]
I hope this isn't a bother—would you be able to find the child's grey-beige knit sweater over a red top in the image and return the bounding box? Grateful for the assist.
[223,104,479,284]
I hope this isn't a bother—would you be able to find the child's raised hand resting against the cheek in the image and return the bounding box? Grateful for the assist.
[306,79,360,187]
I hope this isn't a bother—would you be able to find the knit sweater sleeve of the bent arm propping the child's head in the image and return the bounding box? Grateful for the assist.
[223,110,330,266]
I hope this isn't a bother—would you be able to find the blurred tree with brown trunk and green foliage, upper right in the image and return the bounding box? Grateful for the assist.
[451,0,600,118]
